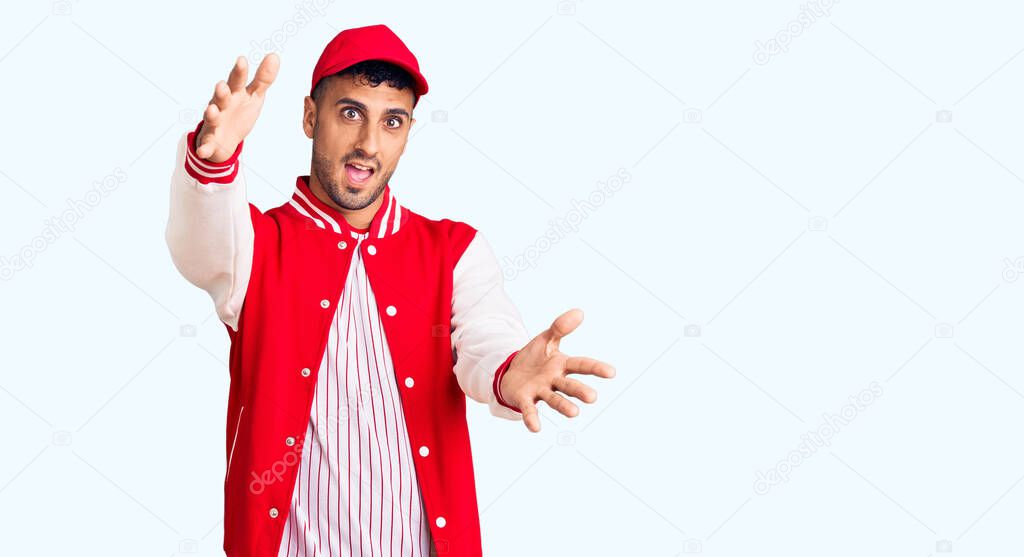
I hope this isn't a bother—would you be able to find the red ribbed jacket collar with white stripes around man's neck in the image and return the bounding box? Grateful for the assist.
[288,175,410,239]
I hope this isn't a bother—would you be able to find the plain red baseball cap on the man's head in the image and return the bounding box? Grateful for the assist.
[309,25,427,106]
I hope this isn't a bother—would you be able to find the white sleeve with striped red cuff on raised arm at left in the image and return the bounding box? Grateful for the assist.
[165,123,255,331]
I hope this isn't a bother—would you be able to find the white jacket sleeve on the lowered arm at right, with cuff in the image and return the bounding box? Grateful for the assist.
[452,231,529,420]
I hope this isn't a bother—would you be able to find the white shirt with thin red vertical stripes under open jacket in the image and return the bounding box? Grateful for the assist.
[279,191,432,557]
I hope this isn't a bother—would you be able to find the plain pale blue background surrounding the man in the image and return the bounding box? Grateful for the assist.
[0,0,1024,557]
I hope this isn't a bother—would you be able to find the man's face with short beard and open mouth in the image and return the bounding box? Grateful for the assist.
[302,75,416,211]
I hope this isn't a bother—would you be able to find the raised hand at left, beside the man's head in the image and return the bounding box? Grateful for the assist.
[195,52,281,163]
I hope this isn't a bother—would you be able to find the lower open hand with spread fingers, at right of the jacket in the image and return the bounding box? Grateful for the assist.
[499,309,615,433]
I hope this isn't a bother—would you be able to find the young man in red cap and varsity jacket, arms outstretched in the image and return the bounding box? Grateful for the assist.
[167,26,614,557]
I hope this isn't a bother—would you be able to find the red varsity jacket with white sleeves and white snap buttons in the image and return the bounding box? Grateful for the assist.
[166,122,529,557]
